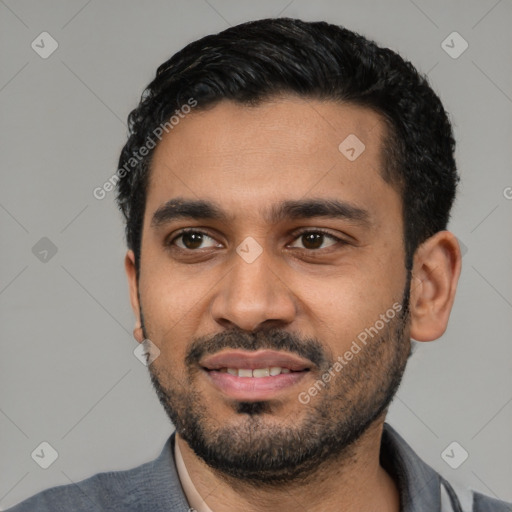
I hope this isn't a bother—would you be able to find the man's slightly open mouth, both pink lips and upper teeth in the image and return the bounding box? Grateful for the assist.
[200,350,314,402]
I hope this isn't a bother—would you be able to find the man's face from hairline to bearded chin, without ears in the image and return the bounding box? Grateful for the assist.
[132,97,410,481]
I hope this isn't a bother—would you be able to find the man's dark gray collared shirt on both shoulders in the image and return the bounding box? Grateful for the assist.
[8,423,512,512]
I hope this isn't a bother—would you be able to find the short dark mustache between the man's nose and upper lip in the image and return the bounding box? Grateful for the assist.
[185,327,332,368]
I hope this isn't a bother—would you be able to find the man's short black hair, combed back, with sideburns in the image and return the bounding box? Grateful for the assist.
[117,18,459,273]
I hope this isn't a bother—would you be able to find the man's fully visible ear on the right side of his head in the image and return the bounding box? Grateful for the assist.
[409,231,462,341]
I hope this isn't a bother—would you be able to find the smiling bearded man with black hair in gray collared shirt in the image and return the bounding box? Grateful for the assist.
[7,18,512,512]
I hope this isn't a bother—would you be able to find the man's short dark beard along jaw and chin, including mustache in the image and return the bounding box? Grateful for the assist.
[141,286,411,487]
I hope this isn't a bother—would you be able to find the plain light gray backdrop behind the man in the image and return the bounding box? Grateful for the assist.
[0,0,512,508]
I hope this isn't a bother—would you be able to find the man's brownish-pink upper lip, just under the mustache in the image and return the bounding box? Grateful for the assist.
[199,349,313,372]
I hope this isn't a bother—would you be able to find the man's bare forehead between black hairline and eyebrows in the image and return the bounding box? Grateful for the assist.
[146,97,396,228]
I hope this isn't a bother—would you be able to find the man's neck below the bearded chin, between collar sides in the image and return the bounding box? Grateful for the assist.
[176,418,400,512]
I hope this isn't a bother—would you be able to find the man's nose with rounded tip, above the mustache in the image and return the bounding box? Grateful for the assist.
[211,245,296,331]
